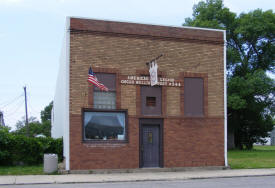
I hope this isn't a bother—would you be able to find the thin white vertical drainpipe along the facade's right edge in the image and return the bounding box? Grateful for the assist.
[223,30,228,166]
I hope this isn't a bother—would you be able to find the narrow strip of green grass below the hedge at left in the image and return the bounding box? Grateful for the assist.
[0,165,44,175]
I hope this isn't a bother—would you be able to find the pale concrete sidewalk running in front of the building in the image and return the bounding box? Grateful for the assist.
[0,168,275,185]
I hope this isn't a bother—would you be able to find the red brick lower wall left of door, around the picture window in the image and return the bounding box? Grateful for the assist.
[70,114,139,170]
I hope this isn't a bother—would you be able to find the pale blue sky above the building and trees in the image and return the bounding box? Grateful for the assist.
[0,0,275,129]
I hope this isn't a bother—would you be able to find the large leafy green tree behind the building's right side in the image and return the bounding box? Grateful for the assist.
[183,0,275,149]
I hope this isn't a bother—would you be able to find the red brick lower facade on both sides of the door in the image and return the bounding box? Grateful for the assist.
[70,114,224,170]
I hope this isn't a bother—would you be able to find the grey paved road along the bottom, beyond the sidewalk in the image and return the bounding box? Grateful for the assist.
[0,176,275,188]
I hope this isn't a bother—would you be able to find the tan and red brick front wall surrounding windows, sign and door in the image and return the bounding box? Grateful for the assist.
[69,19,224,170]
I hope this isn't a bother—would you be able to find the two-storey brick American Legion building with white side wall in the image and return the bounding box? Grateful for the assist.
[52,18,227,170]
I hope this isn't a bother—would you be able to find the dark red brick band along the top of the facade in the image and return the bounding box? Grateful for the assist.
[68,17,224,43]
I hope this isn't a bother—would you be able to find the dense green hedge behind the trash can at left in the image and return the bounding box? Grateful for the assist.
[0,129,63,165]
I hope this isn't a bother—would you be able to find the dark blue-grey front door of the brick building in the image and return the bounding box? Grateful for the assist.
[141,125,160,167]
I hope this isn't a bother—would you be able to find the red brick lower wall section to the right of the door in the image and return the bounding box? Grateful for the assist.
[164,118,224,167]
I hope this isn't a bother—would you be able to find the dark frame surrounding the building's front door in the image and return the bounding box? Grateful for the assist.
[139,118,163,168]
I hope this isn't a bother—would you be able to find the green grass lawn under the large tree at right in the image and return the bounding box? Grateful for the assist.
[228,146,275,169]
